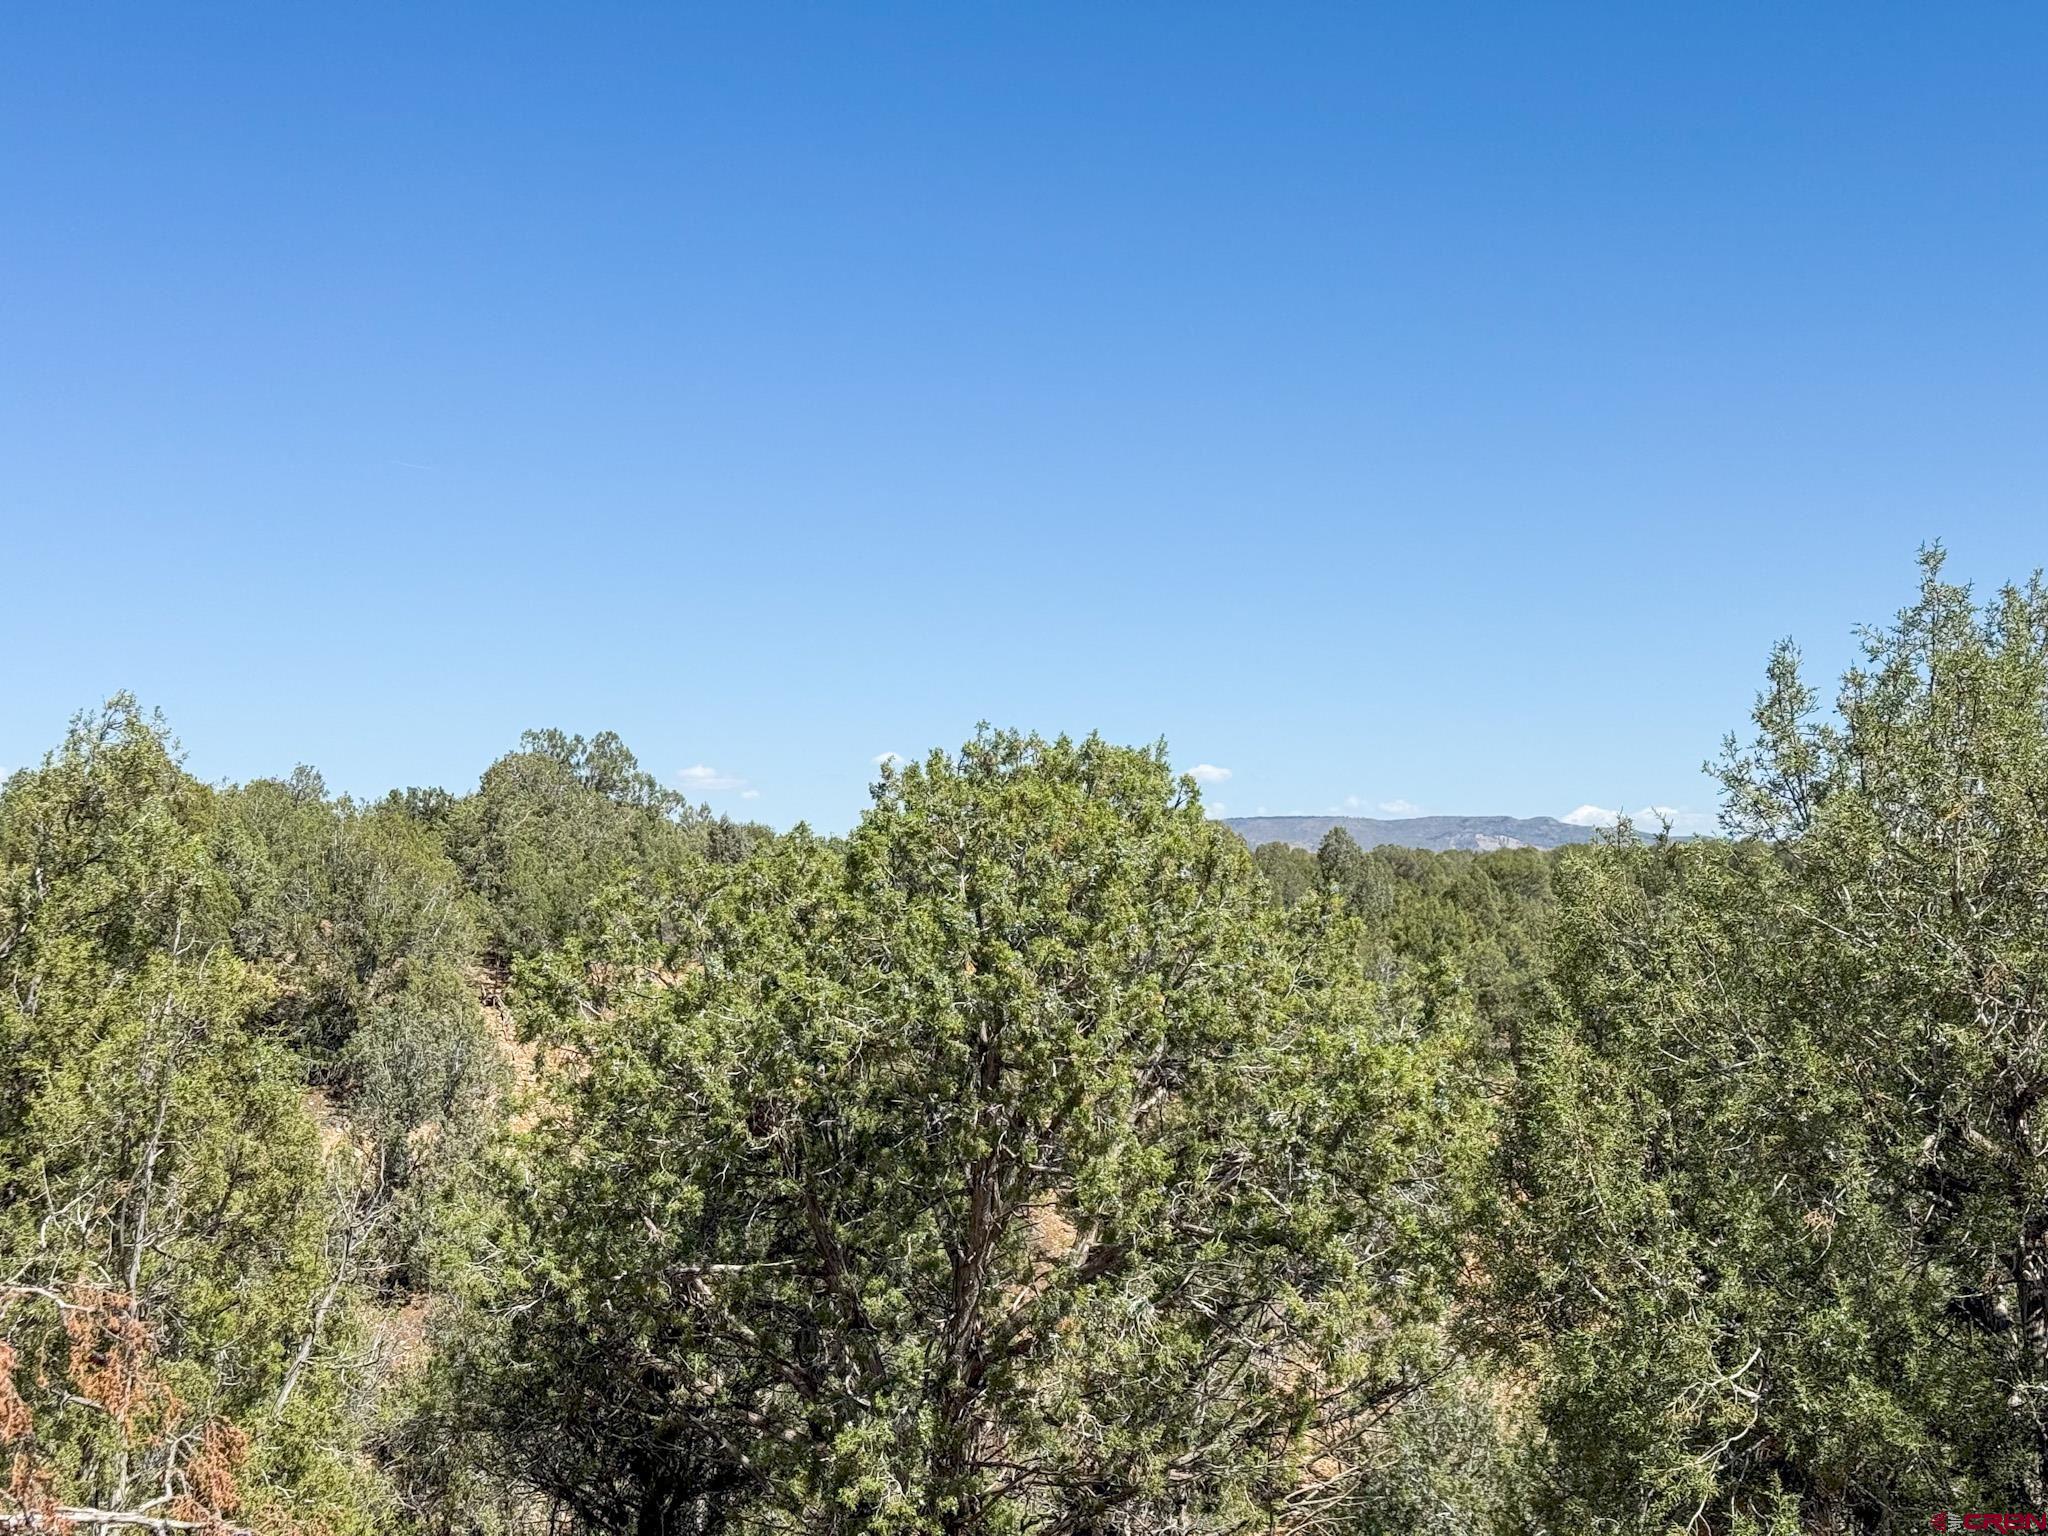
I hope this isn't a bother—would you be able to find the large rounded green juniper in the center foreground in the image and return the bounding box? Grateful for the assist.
[468,733,1462,1532]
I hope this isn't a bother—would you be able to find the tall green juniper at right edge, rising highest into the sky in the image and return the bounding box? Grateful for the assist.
[1509,555,2048,1530]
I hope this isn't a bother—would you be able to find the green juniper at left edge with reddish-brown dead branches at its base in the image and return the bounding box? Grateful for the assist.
[0,698,395,1530]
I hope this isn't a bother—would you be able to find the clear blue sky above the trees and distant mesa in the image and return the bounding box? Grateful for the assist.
[0,2,2048,829]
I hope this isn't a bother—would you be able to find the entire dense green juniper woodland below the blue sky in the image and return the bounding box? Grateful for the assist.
[0,553,2048,1536]
